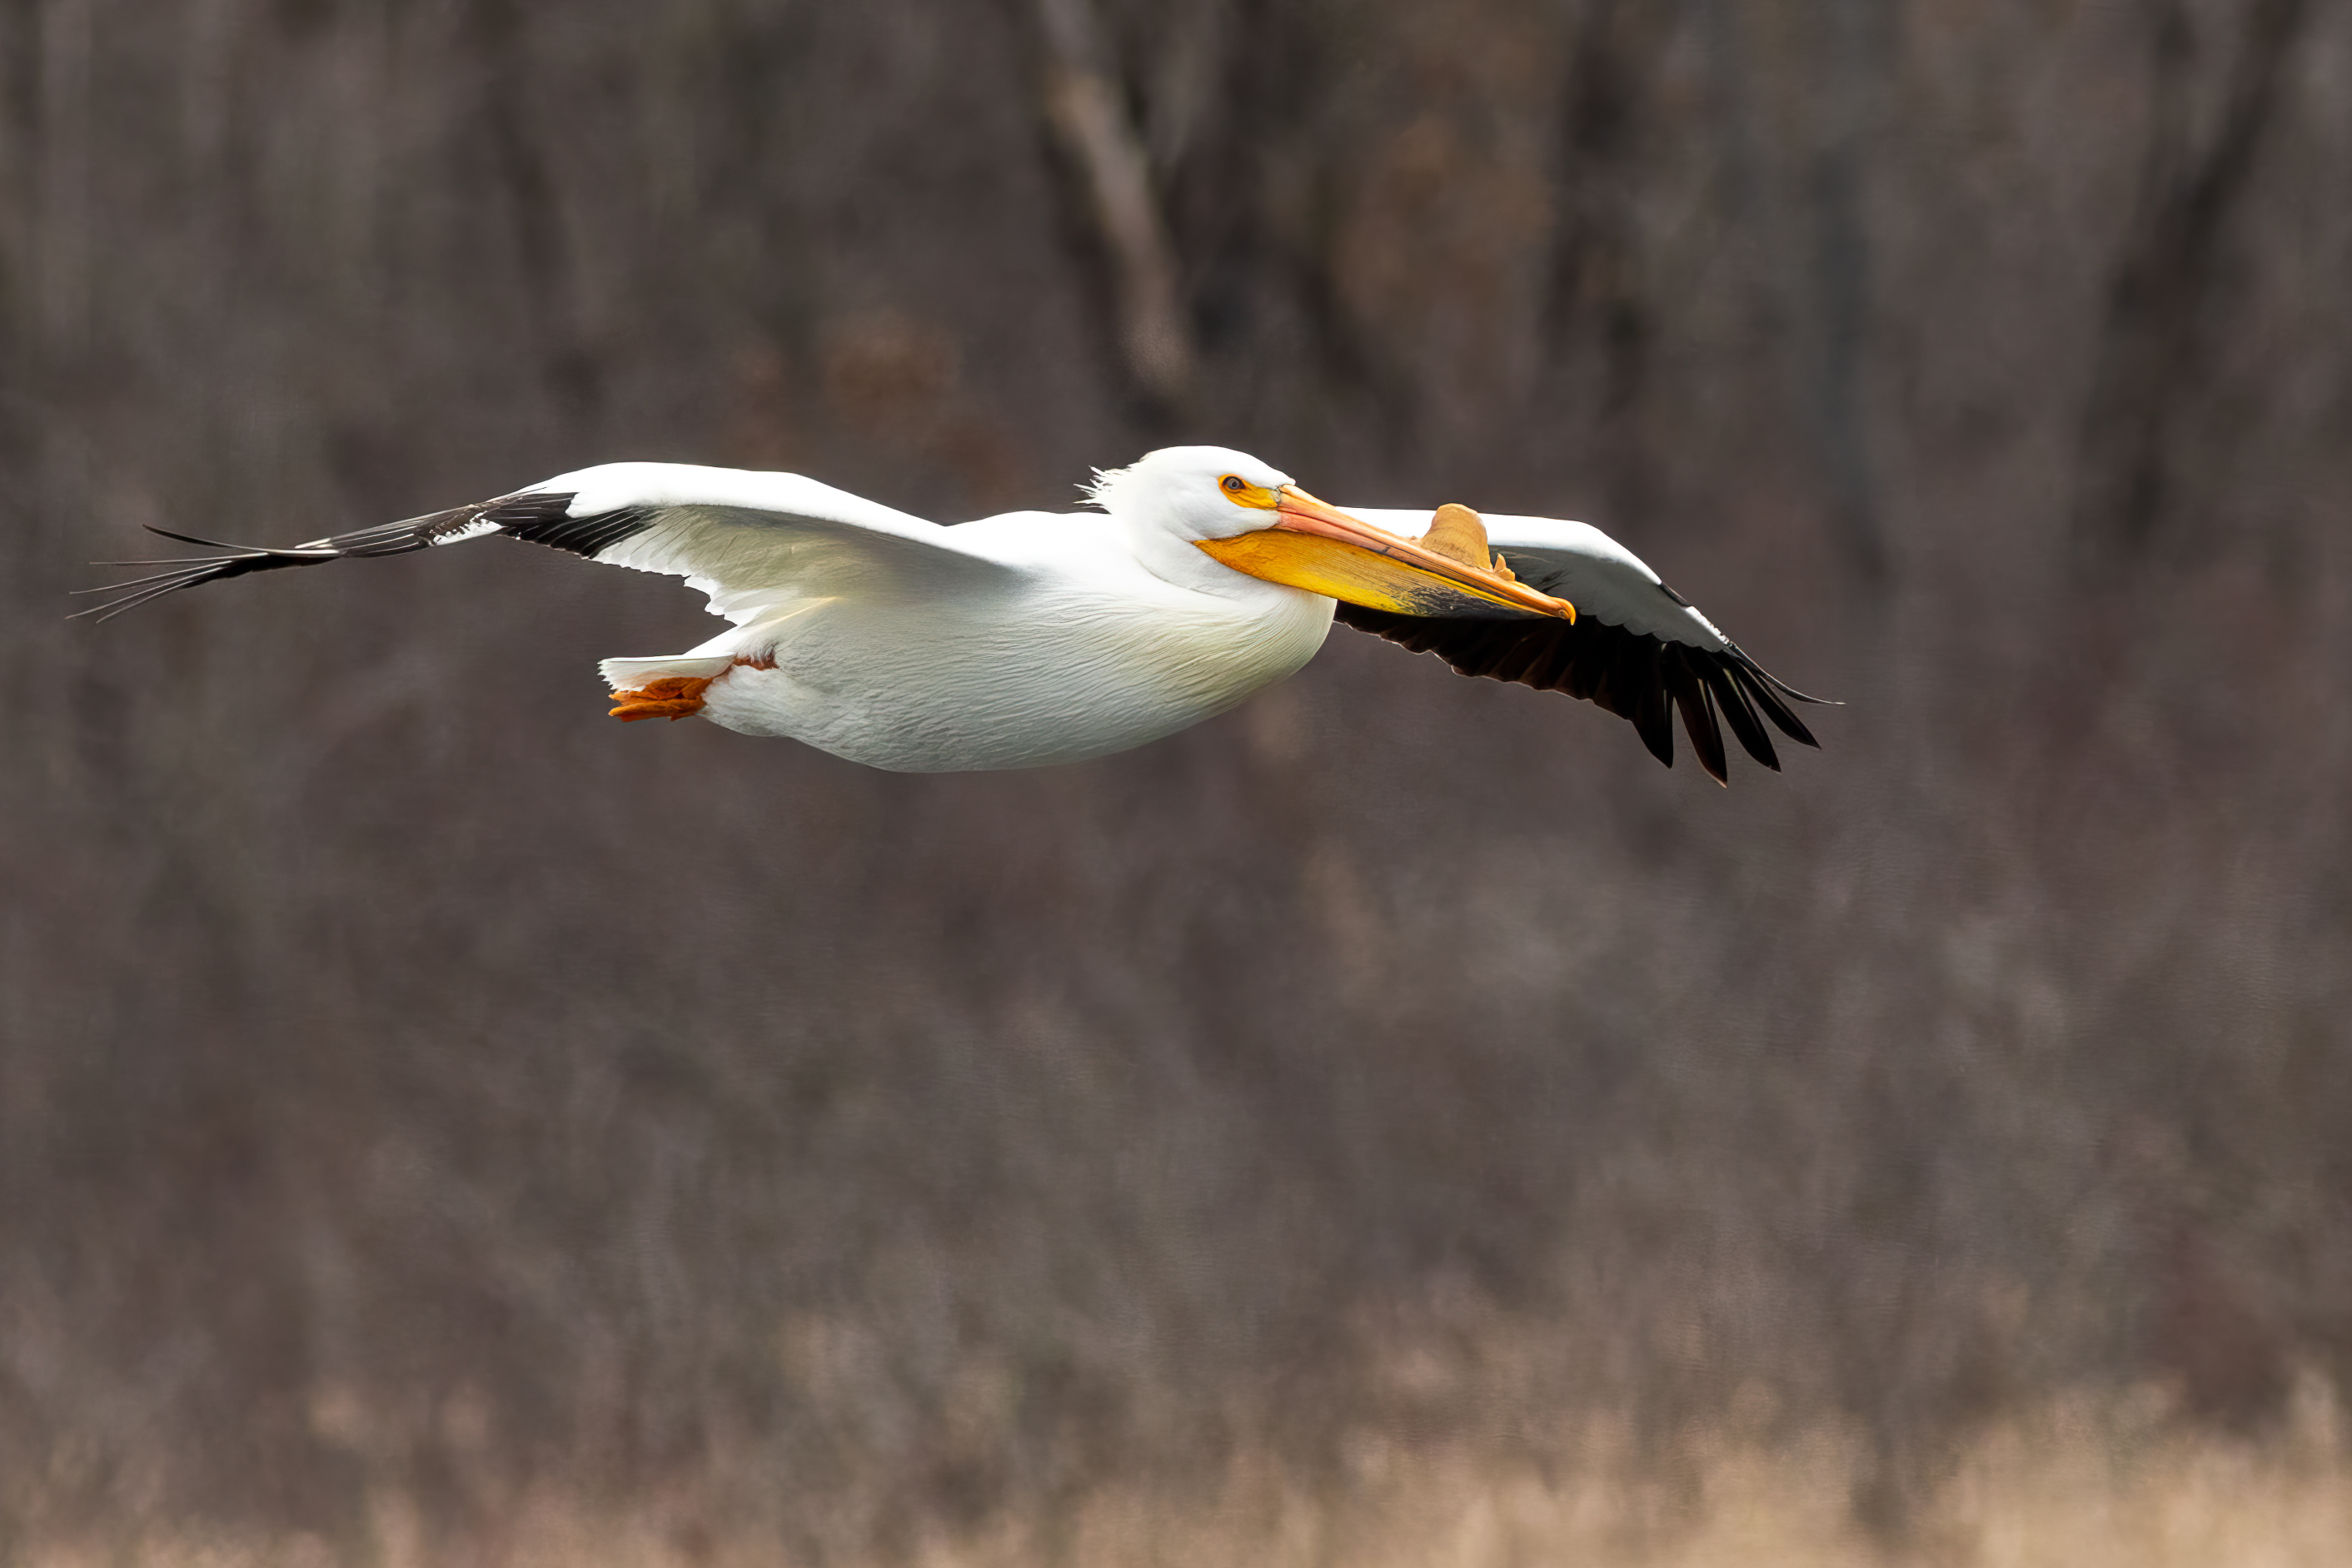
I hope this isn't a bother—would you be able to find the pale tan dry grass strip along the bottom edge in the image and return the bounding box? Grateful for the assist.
[21,1377,2352,1568]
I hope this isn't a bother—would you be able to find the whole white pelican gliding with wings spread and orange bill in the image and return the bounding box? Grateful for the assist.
[82,446,1821,780]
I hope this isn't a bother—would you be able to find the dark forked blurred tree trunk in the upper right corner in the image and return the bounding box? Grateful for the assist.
[2075,0,2305,565]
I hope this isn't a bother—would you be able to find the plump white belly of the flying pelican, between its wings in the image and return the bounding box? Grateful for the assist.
[703,578,1331,774]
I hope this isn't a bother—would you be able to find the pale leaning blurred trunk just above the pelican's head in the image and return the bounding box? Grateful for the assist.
[1033,0,1197,406]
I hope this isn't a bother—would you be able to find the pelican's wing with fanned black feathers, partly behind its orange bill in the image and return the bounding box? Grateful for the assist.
[1338,508,1825,783]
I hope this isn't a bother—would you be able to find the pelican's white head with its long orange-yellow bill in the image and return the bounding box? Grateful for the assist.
[1091,446,1576,620]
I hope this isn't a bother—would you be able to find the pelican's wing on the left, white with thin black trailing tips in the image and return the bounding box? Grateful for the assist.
[80,463,1014,623]
